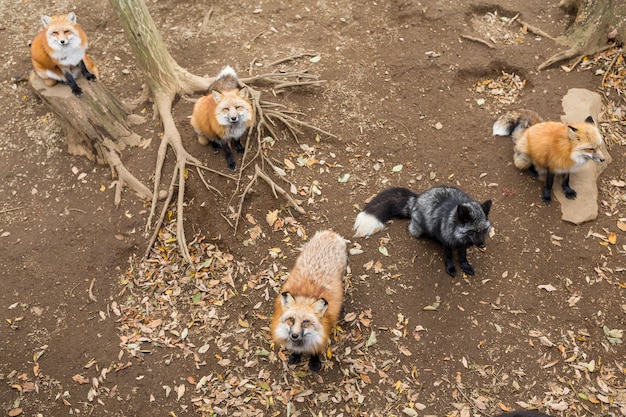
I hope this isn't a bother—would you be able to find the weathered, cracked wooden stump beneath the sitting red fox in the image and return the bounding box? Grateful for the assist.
[29,72,152,206]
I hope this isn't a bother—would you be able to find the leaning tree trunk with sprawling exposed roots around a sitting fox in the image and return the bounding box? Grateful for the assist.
[110,0,332,263]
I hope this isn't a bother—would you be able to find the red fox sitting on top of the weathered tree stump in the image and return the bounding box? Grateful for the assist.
[30,12,99,96]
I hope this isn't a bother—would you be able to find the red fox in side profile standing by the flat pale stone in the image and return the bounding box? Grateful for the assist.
[493,110,604,204]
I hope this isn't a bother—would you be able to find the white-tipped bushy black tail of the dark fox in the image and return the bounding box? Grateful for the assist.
[353,187,418,237]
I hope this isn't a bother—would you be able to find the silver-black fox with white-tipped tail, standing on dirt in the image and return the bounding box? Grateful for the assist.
[354,186,491,277]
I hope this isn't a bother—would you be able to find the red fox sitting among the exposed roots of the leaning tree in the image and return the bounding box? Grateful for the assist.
[191,65,254,171]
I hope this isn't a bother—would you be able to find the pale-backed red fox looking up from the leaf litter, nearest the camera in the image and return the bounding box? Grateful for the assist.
[271,230,348,372]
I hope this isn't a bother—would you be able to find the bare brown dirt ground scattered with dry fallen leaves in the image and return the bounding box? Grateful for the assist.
[0,0,626,417]
